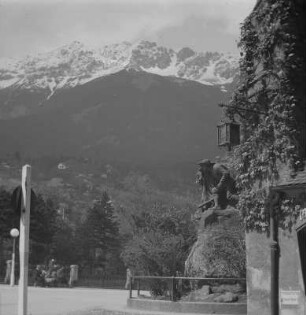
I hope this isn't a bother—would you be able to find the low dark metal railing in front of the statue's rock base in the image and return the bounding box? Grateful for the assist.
[129,276,246,301]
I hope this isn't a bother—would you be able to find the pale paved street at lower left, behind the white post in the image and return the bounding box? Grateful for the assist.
[0,285,129,315]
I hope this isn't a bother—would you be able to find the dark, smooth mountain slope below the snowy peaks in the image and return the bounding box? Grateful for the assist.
[0,70,225,162]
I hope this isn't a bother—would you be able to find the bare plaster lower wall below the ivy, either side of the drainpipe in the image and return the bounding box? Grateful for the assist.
[246,214,306,315]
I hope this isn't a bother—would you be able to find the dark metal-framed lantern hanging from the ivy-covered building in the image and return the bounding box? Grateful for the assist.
[217,120,240,150]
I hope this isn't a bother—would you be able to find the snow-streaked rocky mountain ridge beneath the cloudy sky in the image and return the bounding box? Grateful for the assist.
[0,41,238,94]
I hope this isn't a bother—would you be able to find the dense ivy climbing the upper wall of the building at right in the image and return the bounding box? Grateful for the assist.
[226,0,306,231]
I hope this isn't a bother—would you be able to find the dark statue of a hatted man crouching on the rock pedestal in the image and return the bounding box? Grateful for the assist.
[197,159,238,210]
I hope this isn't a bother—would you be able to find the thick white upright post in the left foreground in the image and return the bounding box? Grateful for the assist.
[18,165,31,315]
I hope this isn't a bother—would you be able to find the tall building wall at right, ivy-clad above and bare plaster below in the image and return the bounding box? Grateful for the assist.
[225,0,306,315]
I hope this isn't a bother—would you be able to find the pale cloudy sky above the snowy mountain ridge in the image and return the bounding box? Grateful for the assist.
[0,0,256,58]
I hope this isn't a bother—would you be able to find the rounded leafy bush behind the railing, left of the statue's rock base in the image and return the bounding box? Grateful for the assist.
[122,203,195,276]
